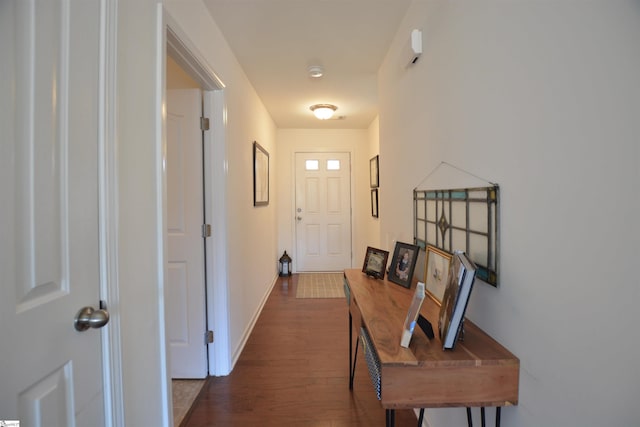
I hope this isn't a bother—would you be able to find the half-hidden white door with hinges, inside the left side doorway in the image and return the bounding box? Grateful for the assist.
[166,89,207,378]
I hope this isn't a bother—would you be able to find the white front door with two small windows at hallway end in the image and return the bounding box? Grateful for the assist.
[294,153,351,271]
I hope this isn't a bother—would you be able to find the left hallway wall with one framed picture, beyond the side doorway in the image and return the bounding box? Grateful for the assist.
[165,1,279,368]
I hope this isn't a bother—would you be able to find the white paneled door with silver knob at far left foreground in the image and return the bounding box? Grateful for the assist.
[0,0,105,427]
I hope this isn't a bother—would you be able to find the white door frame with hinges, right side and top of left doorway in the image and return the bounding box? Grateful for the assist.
[163,10,231,376]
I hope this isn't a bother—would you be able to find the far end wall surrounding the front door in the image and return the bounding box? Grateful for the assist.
[276,129,371,272]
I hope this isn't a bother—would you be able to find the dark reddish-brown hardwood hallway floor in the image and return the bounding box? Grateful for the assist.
[182,275,417,427]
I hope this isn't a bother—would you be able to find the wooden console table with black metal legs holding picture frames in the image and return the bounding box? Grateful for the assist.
[344,269,520,427]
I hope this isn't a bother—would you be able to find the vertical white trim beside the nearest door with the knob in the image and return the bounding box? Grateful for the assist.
[98,0,124,426]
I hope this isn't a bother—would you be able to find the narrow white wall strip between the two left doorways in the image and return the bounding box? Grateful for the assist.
[116,0,171,426]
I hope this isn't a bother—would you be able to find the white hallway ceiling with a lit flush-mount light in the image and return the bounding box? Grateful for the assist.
[204,0,411,129]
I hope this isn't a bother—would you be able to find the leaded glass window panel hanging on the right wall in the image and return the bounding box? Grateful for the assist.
[413,185,500,286]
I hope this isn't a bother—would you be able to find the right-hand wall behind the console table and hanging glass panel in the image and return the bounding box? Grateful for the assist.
[379,0,640,427]
